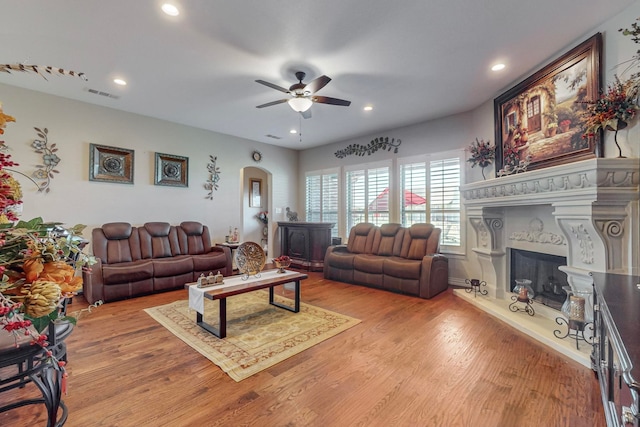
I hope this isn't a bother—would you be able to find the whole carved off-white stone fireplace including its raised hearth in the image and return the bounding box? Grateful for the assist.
[454,158,640,366]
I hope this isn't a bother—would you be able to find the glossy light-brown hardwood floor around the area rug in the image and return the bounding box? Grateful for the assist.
[0,273,605,427]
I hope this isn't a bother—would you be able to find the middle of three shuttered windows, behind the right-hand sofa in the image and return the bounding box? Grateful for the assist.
[346,166,390,232]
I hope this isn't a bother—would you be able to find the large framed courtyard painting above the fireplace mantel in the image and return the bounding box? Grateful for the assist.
[494,33,602,173]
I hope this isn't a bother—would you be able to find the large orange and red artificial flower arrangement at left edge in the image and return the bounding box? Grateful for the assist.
[0,101,101,390]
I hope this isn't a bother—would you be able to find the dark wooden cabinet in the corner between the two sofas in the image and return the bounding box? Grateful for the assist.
[278,222,335,271]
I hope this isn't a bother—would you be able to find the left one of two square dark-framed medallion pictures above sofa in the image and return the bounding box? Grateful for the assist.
[89,144,134,184]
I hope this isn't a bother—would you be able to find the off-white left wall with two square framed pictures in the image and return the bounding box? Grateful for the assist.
[0,83,298,254]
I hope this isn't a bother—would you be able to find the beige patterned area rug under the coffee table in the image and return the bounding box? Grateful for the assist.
[145,291,360,381]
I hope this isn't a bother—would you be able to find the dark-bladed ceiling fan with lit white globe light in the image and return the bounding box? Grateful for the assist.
[256,71,351,119]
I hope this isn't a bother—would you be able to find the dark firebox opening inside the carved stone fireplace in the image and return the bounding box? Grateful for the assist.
[509,248,569,310]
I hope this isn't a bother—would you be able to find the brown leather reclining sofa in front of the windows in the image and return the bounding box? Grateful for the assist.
[324,223,449,298]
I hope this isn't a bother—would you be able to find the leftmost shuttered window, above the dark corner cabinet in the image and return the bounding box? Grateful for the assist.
[305,170,339,237]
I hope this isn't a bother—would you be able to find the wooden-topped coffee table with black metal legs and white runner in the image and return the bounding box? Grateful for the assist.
[185,270,309,338]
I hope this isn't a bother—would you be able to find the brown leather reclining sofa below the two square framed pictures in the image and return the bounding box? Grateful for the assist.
[83,221,233,304]
